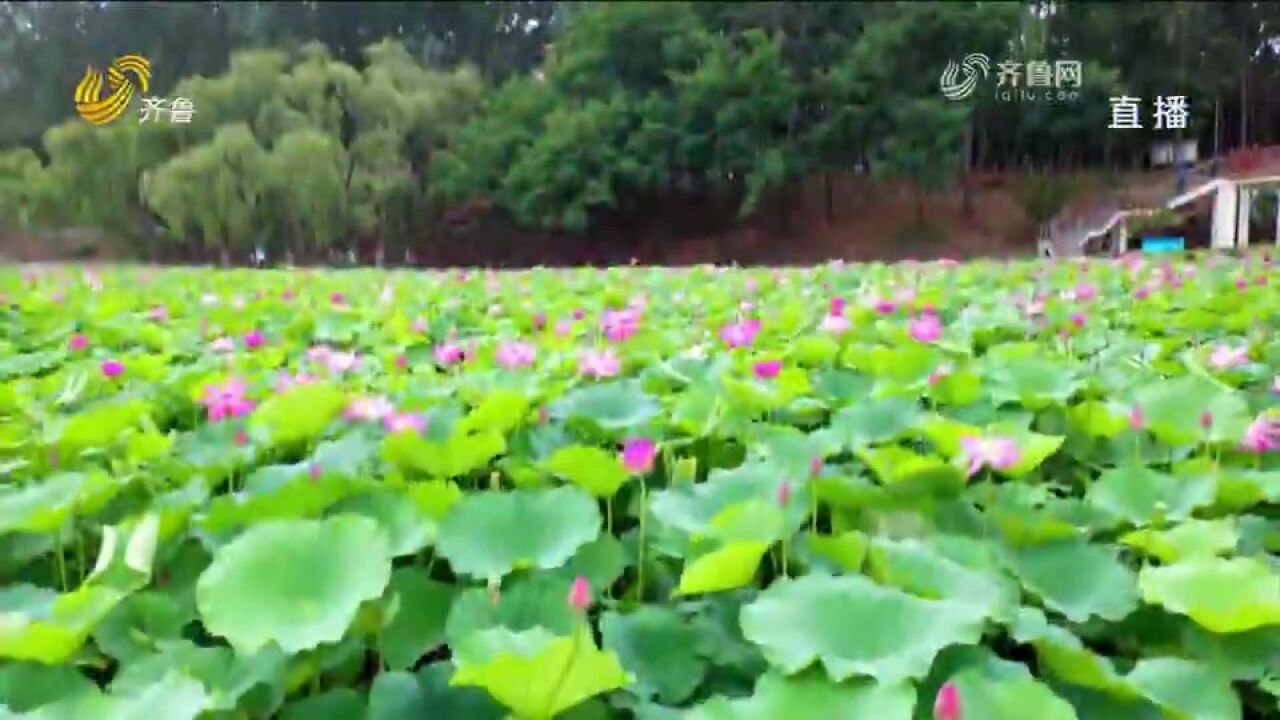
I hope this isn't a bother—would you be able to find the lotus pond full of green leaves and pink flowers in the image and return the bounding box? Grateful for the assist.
[0,255,1280,720]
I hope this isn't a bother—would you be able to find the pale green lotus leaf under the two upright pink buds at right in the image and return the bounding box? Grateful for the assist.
[1085,465,1217,527]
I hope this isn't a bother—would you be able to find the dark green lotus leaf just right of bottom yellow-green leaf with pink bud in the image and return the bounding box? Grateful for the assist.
[600,606,707,703]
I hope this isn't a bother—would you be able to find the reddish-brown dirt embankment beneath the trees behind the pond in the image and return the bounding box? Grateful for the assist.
[0,174,1095,266]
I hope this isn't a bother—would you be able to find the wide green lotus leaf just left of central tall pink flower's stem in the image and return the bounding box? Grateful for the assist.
[435,487,600,580]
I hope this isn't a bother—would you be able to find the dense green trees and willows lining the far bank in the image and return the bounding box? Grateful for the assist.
[0,1,1280,259]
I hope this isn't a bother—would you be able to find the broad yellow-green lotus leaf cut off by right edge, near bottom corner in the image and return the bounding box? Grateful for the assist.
[1138,557,1280,633]
